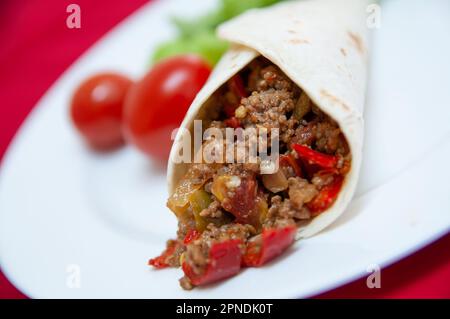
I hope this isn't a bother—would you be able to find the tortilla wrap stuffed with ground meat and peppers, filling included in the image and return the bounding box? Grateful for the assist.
[150,0,368,289]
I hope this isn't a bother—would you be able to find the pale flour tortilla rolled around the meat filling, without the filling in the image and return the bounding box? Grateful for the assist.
[168,0,368,238]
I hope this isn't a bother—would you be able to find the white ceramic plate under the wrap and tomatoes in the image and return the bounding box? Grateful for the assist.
[0,0,450,298]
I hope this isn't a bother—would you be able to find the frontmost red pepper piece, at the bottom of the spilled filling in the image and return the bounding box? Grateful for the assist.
[182,239,242,286]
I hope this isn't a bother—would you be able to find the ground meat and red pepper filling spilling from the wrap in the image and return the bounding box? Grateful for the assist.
[160,56,352,289]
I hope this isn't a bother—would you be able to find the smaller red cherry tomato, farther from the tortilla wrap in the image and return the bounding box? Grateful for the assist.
[70,73,132,150]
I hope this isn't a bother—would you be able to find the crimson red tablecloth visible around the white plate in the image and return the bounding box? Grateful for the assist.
[0,0,450,298]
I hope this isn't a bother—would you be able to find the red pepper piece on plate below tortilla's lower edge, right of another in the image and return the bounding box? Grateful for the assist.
[242,226,297,267]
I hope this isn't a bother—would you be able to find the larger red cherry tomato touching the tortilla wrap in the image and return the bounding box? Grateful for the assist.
[124,55,211,161]
